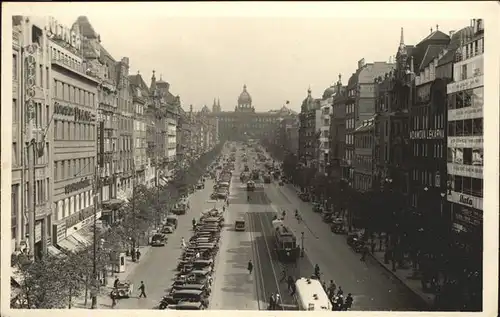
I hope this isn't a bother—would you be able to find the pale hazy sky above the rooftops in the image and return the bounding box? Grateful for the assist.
[4,2,492,111]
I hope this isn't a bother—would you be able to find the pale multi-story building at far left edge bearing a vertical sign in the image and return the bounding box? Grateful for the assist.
[11,16,53,257]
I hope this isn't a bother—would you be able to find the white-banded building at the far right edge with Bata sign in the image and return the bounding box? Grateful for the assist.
[446,19,484,302]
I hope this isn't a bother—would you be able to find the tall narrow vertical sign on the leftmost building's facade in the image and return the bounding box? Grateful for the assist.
[24,44,37,140]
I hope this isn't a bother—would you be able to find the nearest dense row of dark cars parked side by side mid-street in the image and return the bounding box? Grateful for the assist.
[159,208,224,310]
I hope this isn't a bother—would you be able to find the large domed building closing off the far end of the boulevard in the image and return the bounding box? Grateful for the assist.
[210,85,294,140]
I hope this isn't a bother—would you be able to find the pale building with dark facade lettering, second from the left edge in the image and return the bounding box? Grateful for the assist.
[49,17,101,250]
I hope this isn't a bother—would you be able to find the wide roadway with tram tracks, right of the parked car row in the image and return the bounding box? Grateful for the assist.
[210,147,424,311]
